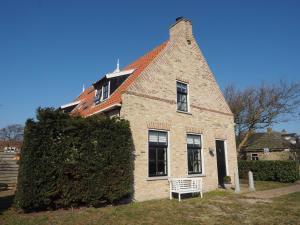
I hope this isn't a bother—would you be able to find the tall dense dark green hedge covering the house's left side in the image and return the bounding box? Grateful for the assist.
[15,108,133,211]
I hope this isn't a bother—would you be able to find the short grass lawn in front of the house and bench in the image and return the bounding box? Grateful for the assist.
[0,182,300,225]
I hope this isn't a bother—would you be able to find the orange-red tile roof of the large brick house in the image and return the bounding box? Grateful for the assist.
[72,41,168,117]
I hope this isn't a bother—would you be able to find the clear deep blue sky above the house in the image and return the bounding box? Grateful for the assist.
[0,0,300,133]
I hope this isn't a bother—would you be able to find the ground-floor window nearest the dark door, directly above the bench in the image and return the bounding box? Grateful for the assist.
[187,134,202,174]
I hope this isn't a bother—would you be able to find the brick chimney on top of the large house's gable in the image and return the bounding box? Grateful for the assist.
[169,16,193,41]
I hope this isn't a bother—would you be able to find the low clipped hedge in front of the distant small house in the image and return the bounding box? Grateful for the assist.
[238,160,299,183]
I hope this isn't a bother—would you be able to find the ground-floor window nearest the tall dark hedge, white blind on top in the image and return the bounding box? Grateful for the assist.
[148,130,168,177]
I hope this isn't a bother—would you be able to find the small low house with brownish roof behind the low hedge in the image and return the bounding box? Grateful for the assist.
[241,128,300,160]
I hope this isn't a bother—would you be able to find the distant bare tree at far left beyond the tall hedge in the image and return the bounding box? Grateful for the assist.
[0,124,24,142]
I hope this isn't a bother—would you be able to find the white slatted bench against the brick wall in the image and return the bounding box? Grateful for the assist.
[169,178,203,201]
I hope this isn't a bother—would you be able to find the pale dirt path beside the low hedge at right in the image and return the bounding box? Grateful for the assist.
[245,182,300,199]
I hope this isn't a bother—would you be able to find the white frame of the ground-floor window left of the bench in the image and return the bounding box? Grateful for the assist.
[147,128,171,180]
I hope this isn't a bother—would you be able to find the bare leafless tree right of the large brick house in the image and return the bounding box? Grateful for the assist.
[224,81,300,151]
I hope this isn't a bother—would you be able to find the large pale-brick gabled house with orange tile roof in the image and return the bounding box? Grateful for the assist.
[61,17,237,201]
